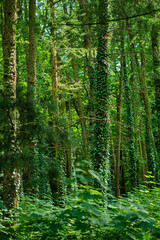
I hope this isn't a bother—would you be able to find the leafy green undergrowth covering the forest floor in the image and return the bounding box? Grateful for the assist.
[0,185,160,240]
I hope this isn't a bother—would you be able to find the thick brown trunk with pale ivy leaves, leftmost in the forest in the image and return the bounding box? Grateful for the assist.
[3,0,19,209]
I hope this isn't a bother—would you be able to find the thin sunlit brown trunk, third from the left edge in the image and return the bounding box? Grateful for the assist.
[48,0,65,207]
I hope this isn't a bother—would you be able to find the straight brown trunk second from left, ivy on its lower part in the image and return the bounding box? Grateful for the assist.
[23,0,39,195]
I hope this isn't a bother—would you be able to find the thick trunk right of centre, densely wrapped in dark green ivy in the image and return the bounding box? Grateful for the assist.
[93,0,109,186]
